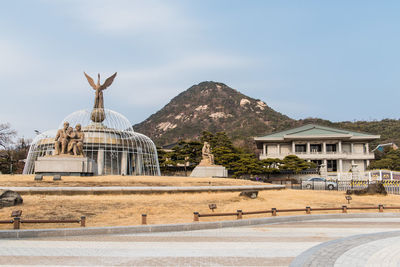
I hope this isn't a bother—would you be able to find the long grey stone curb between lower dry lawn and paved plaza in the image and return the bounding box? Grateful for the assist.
[0,213,400,241]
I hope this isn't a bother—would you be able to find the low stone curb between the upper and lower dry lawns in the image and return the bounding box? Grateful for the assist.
[1,185,285,195]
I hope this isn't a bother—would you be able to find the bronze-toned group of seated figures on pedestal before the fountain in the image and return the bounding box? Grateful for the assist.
[54,122,85,156]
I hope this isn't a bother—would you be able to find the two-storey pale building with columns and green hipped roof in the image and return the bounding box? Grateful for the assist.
[254,124,380,172]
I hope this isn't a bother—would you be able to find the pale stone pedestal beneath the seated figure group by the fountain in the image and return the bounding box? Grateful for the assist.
[35,155,97,176]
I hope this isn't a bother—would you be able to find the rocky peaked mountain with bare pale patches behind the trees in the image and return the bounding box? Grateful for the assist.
[133,82,297,147]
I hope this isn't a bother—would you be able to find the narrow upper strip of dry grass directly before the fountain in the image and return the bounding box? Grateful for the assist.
[0,175,265,188]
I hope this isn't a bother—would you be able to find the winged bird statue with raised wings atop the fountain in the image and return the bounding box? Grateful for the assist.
[83,72,117,122]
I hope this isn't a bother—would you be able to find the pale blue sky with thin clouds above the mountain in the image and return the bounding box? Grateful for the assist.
[0,0,400,138]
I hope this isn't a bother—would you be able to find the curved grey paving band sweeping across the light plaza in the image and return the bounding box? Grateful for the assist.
[290,231,400,267]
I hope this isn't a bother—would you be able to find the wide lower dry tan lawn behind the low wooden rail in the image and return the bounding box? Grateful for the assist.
[0,188,400,229]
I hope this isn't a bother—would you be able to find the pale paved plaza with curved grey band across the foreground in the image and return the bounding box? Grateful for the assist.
[0,216,400,266]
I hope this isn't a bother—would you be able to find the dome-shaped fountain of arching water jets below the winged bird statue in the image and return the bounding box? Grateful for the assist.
[23,109,160,175]
